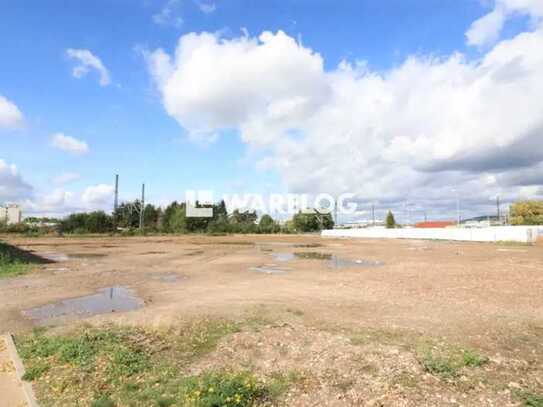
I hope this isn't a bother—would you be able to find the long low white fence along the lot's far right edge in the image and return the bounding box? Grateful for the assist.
[321,226,539,243]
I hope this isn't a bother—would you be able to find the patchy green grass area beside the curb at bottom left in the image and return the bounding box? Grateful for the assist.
[16,319,302,407]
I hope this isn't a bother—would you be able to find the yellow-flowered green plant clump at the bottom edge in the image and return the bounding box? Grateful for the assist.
[182,372,267,407]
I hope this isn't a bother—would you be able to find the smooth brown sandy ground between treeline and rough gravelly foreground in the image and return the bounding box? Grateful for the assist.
[0,236,543,405]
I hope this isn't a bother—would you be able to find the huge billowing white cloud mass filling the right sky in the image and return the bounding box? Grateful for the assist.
[148,22,543,218]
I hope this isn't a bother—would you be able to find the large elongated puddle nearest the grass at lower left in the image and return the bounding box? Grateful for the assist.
[23,286,143,325]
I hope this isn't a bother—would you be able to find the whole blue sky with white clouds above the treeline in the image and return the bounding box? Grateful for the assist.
[0,0,543,221]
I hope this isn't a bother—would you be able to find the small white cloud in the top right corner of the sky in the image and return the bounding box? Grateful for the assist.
[466,0,543,46]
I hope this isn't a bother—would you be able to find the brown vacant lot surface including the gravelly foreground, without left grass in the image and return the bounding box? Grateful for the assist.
[0,236,543,406]
